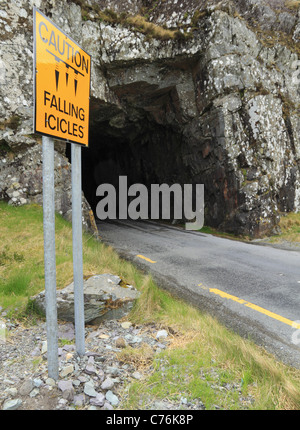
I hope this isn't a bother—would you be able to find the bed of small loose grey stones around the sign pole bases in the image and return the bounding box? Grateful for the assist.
[0,319,170,410]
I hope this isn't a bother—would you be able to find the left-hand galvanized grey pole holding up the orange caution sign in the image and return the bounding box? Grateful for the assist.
[42,136,58,380]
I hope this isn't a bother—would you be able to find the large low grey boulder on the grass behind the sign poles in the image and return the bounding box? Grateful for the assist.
[32,274,139,324]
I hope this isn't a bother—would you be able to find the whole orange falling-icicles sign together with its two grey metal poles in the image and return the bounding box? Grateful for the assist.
[33,7,91,379]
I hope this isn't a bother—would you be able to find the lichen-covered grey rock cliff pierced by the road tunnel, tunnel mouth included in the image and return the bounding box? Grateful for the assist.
[0,0,300,237]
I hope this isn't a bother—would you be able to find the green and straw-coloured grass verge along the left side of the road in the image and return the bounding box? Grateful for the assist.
[0,202,300,410]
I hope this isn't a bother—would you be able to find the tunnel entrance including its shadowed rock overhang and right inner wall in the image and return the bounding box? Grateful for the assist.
[65,58,239,235]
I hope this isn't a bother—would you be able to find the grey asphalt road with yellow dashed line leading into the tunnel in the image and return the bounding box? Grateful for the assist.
[98,221,300,368]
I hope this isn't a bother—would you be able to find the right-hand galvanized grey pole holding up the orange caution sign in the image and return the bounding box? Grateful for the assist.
[71,143,85,356]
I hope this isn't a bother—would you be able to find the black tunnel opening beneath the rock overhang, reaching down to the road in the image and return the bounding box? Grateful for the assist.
[67,98,227,232]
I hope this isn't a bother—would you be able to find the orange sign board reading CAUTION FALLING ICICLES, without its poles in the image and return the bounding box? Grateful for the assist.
[33,8,91,146]
